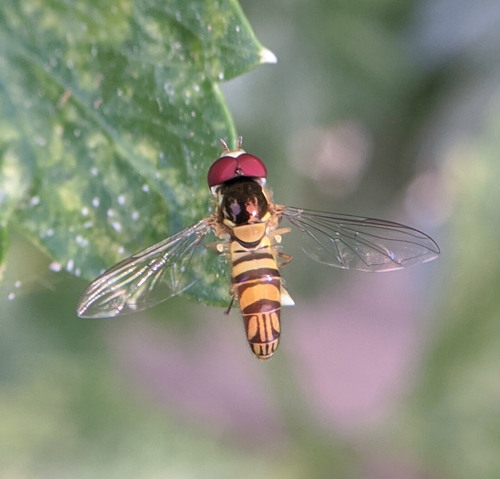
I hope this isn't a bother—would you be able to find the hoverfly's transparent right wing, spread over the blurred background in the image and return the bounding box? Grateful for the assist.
[276,206,439,271]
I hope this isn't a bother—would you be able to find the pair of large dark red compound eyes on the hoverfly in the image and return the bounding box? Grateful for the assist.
[207,153,267,188]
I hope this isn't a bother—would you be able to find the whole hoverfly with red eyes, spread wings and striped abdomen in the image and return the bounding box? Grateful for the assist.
[77,137,440,359]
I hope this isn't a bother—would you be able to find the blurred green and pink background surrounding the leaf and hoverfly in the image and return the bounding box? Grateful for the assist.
[0,0,500,479]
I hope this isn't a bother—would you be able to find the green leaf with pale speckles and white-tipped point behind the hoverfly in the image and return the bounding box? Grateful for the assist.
[0,0,273,303]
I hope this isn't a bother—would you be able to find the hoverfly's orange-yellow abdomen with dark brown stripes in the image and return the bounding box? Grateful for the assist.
[231,237,281,359]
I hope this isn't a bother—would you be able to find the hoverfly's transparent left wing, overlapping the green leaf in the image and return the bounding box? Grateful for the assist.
[77,217,211,318]
